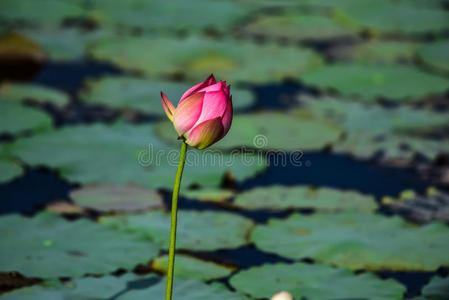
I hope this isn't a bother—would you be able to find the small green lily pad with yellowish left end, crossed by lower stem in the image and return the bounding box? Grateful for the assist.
[151,254,233,281]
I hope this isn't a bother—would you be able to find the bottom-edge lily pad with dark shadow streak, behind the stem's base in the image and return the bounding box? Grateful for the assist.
[0,274,248,300]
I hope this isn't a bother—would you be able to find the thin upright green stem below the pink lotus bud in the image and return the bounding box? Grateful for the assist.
[165,141,187,300]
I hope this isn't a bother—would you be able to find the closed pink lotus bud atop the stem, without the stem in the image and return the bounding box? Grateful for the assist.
[161,75,232,149]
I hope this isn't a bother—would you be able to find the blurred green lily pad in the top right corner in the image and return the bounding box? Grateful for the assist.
[335,0,449,35]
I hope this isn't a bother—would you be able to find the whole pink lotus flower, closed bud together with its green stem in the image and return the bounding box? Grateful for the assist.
[161,74,233,300]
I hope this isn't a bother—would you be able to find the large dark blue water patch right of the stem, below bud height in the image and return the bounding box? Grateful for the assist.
[239,152,432,198]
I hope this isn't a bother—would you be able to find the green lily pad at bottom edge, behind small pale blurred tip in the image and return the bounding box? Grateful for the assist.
[230,263,406,300]
